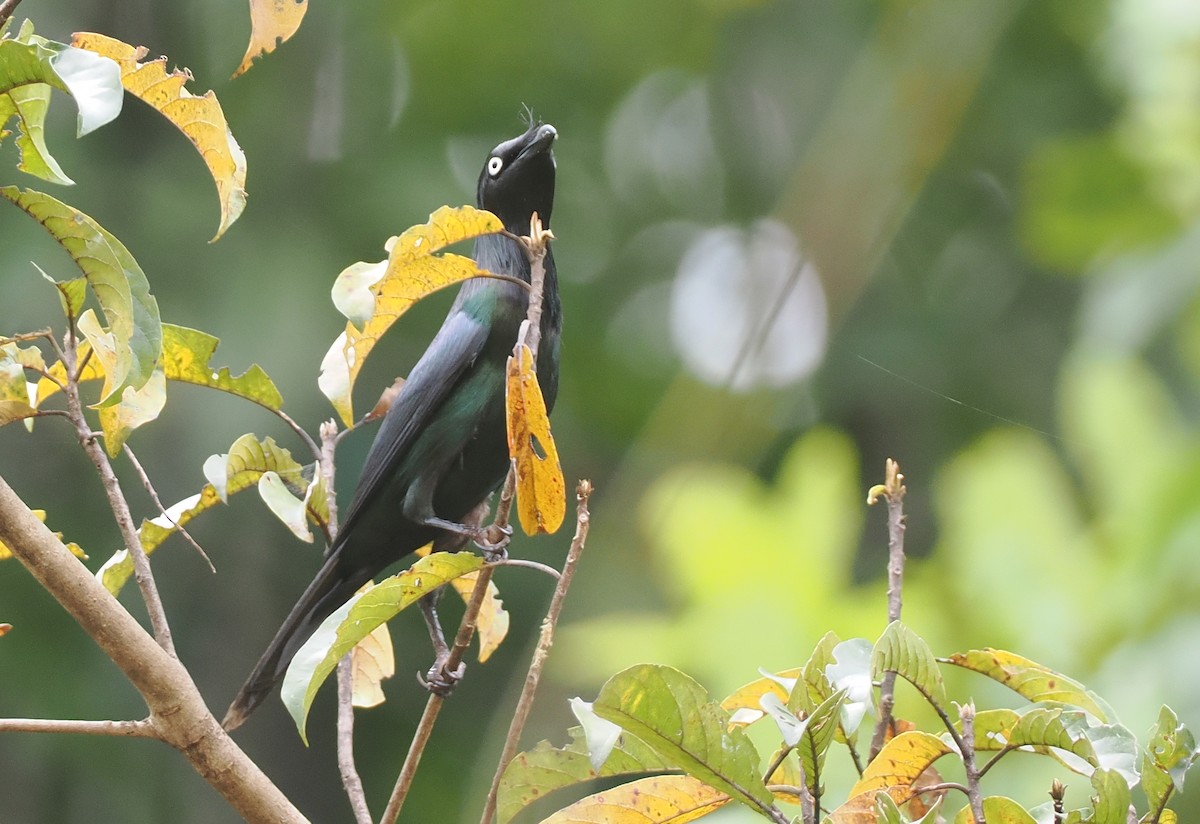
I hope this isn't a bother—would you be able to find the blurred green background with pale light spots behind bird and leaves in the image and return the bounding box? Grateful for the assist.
[0,0,1200,824]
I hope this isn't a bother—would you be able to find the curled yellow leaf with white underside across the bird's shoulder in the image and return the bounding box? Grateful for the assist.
[317,206,504,426]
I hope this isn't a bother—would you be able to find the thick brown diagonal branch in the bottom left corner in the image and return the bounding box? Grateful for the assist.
[0,477,306,824]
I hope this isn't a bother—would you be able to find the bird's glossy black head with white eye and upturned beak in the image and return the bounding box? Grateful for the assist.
[478,122,558,235]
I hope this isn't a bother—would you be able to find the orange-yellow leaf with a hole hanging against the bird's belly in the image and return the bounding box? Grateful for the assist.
[506,343,566,535]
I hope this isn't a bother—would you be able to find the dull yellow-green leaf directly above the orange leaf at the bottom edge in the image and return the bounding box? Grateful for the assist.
[497,727,676,824]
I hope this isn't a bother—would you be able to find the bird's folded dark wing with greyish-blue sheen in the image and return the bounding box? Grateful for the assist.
[335,307,488,547]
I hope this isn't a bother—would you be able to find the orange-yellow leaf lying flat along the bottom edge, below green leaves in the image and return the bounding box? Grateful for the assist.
[542,775,731,824]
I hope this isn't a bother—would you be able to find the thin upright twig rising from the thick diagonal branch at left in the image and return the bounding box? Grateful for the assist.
[62,329,178,657]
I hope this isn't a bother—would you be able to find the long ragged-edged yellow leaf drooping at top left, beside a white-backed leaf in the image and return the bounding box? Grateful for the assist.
[71,31,246,240]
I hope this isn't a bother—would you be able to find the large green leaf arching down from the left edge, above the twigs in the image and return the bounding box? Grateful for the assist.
[0,186,162,405]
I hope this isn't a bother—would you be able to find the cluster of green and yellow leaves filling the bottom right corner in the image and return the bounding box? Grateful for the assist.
[498,621,1200,824]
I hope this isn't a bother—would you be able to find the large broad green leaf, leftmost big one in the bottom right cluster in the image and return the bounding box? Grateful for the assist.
[593,664,773,811]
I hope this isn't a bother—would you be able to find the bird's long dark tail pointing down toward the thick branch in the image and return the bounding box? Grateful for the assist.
[221,555,366,729]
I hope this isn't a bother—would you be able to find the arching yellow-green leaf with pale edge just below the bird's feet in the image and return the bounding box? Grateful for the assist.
[282,552,484,745]
